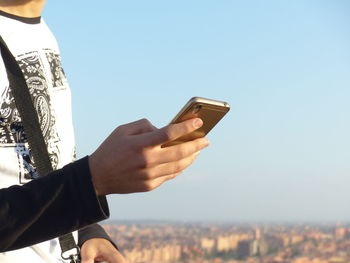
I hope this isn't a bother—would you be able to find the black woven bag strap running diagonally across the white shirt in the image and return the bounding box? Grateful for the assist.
[0,36,80,262]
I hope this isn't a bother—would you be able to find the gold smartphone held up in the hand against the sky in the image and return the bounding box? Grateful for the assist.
[162,97,230,147]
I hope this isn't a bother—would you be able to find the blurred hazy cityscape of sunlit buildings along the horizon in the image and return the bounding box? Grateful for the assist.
[104,222,350,263]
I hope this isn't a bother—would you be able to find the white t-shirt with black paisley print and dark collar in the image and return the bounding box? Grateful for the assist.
[0,11,75,263]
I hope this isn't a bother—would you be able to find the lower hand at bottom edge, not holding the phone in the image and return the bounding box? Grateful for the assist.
[80,238,127,263]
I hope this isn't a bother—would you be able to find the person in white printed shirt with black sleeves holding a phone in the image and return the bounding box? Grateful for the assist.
[0,0,208,263]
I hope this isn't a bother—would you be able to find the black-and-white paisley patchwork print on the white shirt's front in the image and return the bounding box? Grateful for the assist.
[0,51,64,183]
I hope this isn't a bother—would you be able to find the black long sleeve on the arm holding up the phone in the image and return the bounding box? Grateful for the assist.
[0,157,109,252]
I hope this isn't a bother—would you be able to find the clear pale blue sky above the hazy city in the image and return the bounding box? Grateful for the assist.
[44,0,350,221]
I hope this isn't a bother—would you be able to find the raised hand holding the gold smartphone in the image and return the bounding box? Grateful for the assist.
[89,118,208,195]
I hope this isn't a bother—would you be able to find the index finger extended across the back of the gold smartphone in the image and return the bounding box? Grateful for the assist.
[139,118,203,147]
